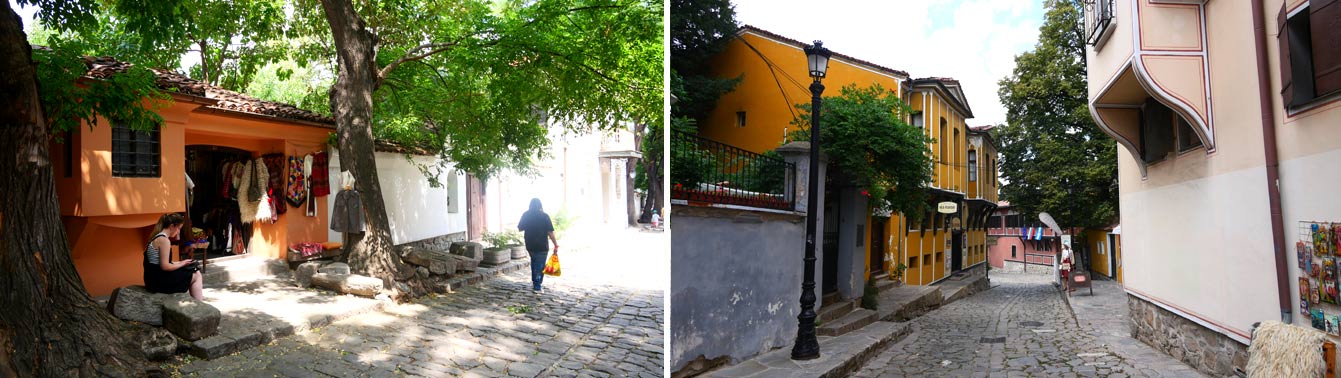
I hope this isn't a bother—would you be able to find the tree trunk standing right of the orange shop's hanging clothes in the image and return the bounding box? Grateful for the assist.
[322,0,404,296]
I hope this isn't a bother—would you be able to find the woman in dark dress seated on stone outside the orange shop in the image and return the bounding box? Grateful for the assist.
[145,213,205,300]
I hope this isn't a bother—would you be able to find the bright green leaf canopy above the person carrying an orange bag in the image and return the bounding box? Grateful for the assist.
[365,0,664,178]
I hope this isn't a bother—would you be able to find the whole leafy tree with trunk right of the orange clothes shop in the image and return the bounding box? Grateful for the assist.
[296,0,662,296]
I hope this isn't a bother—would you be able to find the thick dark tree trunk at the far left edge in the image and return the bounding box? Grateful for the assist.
[0,3,146,377]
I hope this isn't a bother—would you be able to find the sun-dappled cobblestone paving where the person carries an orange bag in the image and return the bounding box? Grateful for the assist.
[174,226,665,377]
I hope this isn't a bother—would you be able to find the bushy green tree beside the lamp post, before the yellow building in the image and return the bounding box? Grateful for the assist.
[787,84,932,217]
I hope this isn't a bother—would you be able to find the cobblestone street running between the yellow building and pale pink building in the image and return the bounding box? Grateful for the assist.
[854,272,1200,377]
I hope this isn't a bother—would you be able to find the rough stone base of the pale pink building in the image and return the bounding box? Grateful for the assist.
[1126,295,1248,377]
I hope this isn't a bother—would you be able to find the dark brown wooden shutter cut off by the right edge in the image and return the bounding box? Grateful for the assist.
[1309,0,1341,97]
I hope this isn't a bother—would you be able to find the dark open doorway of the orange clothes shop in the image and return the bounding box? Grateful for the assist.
[182,145,252,260]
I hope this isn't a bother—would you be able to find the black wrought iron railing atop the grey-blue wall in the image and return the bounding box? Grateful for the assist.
[671,131,797,210]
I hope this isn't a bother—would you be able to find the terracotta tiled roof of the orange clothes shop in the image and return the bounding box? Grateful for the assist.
[84,56,335,127]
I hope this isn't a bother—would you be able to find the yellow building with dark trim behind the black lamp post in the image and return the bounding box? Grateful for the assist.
[699,25,999,288]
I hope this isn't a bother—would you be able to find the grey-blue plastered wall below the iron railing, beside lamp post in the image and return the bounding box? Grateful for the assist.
[671,205,804,371]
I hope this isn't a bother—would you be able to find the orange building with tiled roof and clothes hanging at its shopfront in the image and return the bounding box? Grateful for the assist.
[59,58,334,296]
